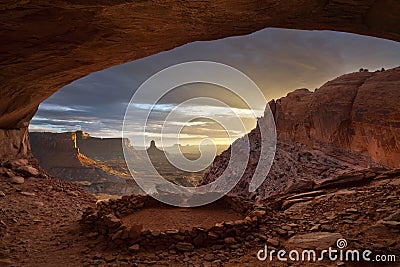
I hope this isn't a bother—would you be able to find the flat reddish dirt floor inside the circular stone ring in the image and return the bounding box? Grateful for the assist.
[122,205,243,231]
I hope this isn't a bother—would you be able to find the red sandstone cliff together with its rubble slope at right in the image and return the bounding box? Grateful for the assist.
[201,68,400,198]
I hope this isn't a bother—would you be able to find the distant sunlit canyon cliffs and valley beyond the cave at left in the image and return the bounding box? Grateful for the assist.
[30,131,203,195]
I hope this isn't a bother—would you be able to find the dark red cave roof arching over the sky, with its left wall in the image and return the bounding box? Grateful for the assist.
[0,0,400,159]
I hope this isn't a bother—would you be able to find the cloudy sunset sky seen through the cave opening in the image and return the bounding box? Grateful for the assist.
[30,28,400,146]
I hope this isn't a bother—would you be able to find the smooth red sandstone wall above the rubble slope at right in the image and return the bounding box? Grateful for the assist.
[270,68,400,167]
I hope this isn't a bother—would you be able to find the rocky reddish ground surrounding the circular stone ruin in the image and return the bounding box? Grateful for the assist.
[0,160,400,266]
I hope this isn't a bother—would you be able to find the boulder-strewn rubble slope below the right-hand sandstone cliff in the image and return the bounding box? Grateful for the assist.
[200,133,388,199]
